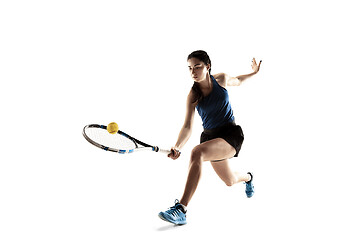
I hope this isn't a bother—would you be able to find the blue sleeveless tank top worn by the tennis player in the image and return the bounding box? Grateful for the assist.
[196,75,235,129]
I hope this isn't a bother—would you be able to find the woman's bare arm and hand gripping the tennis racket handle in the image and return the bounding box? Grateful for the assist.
[168,90,196,160]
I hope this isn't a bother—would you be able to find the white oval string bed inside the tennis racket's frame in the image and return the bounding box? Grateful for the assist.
[85,128,136,150]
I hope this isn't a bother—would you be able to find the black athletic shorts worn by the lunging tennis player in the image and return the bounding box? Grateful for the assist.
[200,122,244,157]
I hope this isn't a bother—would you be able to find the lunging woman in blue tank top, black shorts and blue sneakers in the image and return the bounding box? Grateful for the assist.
[159,50,261,225]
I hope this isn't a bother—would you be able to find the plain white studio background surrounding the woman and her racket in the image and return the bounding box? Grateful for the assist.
[0,0,360,240]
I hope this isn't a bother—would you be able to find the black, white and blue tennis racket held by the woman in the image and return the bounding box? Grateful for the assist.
[83,124,171,154]
